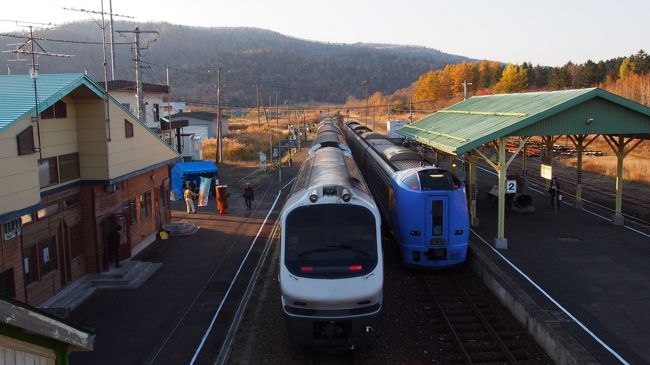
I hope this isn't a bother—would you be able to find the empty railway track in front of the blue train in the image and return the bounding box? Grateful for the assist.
[418,272,535,364]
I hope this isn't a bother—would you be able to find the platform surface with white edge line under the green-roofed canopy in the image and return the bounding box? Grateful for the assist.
[470,176,650,364]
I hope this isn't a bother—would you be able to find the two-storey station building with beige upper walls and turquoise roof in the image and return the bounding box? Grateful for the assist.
[0,74,179,305]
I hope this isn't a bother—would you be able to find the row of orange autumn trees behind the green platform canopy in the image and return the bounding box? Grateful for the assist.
[346,50,650,116]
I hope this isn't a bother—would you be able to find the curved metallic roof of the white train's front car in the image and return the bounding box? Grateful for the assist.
[291,147,370,195]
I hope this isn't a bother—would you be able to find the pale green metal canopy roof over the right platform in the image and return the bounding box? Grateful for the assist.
[397,88,650,155]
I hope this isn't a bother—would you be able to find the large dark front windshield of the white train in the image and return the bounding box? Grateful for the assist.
[285,204,377,278]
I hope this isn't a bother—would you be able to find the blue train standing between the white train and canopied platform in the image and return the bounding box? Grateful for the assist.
[342,120,469,268]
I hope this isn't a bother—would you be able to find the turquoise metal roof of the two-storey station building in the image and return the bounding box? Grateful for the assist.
[0,73,104,132]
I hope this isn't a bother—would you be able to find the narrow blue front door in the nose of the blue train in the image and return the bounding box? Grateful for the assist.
[426,195,450,260]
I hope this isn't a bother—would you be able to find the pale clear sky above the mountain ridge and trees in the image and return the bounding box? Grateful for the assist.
[0,0,650,66]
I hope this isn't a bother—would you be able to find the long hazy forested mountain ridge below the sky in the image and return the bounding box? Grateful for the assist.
[0,22,470,105]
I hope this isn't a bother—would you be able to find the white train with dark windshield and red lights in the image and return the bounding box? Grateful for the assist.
[279,123,384,350]
